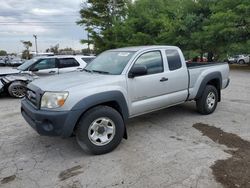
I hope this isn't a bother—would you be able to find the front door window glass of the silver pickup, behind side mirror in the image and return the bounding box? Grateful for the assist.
[134,51,164,75]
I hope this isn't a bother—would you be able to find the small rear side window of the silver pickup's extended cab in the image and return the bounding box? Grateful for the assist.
[166,50,182,71]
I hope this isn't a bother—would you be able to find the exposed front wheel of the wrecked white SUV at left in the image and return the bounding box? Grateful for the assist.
[8,81,26,98]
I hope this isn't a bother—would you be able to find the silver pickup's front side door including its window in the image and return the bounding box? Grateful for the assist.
[127,50,167,116]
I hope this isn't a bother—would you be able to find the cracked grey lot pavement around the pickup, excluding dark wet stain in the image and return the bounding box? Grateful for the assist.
[0,71,250,188]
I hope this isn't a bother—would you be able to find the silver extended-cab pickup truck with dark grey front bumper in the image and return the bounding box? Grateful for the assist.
[21,46,229,154]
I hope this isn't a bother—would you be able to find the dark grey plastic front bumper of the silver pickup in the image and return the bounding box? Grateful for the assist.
[21,99,81,137]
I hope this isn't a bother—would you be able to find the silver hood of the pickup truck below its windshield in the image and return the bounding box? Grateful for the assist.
[31,72,112,91]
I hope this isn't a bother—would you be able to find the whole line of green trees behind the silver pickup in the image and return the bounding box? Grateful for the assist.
[77,0,250,61]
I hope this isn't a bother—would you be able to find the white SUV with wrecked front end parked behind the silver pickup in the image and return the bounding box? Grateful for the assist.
[0,55,94,98]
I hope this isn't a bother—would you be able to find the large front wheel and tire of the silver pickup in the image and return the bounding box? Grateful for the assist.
[76,106,125,155]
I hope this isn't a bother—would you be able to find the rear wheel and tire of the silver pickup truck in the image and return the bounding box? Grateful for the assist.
[196,85,218,115]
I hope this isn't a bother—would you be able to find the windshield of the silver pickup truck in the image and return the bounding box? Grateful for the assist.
[84,51,135,75]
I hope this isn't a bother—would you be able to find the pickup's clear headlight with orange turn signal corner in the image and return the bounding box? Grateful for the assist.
[41,92,69,109]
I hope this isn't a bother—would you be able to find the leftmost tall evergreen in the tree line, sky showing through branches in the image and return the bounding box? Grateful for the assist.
[77,0,129,53]
